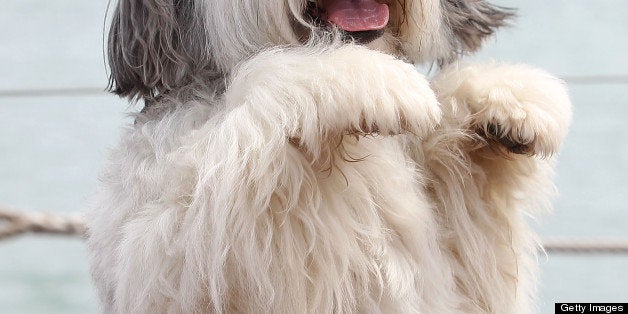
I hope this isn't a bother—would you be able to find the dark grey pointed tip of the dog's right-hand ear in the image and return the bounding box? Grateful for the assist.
[443,0,515,52]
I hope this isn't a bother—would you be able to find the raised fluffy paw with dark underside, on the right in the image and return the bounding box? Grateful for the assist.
[440,65,571,156]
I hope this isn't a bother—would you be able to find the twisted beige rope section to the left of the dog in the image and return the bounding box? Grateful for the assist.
[0,208,87,240]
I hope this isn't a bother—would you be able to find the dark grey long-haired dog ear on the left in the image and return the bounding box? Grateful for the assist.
[108,0,208,99]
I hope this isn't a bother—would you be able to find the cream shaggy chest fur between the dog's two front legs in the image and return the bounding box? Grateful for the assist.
[268,138,450,309]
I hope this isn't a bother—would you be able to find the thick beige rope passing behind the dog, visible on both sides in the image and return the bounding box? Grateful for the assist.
[0,208,628,254]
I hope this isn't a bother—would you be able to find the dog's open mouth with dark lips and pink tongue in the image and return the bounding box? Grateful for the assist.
[307,0,390,44]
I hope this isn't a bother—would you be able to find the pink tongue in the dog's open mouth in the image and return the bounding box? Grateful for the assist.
[323,0,389,32]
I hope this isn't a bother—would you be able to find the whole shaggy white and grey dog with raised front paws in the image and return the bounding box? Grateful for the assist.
[89,0,571,313]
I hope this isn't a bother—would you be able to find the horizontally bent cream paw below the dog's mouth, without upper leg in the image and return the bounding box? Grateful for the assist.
[223,45,441,154]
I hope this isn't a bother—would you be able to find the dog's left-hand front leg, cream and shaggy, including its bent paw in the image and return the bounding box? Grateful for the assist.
[173,45,440,312]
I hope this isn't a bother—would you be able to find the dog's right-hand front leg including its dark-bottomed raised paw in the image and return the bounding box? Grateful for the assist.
[427,65,571,313]
